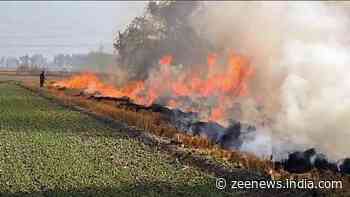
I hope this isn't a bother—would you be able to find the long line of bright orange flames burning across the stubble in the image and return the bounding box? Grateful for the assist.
[56,53,254,122]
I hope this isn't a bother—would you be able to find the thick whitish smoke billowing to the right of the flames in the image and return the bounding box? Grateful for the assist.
[192,2,350,159]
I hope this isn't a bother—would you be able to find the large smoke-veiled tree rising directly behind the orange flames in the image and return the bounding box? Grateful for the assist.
[114,1,212,79]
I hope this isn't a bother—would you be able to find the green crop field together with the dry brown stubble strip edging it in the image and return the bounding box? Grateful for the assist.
[0,73,348,196]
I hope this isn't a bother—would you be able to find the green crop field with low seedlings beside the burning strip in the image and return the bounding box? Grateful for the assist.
[0,83,238,196]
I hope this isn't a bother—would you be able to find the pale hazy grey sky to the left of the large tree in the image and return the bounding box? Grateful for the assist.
[0,1,146,56]
